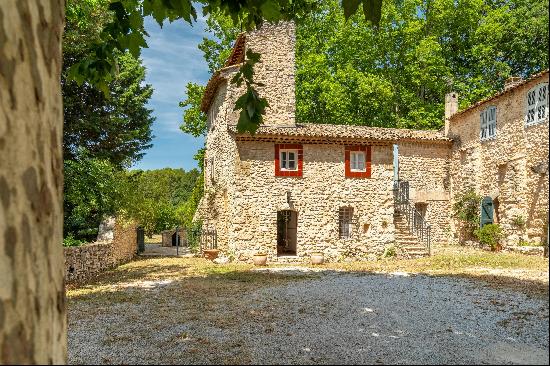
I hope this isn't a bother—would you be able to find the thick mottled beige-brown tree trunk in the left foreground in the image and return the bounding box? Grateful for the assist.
[0,0,67,364]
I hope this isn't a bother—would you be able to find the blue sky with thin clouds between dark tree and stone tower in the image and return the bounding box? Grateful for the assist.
[132,17,210,170]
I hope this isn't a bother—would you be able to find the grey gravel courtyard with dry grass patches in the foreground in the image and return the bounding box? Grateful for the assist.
[68,258,549,364]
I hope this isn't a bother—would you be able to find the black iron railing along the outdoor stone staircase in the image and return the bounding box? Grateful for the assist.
[393,180,432,255]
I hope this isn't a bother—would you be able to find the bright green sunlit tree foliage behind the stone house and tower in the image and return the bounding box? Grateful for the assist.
[182,0,549,133]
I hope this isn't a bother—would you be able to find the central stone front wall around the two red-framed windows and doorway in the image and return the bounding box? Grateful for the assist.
[227,142,394,261]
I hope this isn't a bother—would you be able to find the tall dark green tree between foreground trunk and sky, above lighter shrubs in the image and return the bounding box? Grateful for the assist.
[61,0,154,167]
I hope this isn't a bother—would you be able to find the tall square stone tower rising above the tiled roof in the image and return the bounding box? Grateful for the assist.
[246,22,296,127]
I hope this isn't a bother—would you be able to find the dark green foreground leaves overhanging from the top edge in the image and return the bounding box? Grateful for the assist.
[69,0,382,133]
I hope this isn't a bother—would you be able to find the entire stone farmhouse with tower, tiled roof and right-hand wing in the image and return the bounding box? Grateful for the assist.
[195,23,548,262]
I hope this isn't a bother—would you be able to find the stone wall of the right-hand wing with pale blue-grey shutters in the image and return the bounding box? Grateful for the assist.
[449,73,549,245]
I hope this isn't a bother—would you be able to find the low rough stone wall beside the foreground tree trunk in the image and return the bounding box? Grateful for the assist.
[64,223,137,282]
